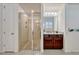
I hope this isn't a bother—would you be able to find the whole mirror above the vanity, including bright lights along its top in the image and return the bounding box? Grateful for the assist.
[43,12,58,33]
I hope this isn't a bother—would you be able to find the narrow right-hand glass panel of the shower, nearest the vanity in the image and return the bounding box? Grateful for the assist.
[33,12,41,51]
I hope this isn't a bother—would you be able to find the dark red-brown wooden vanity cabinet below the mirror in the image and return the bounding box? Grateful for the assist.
[43,34,63,49]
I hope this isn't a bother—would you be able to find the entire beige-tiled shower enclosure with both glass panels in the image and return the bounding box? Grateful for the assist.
[19,3,41,51]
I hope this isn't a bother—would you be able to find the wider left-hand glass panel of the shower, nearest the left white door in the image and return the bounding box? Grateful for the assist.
[19,13,32,51]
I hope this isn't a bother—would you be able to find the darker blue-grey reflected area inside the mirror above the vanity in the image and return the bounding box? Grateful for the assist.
[43,17,54,32]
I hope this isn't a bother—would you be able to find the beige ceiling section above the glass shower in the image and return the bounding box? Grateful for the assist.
[19,3,41,13]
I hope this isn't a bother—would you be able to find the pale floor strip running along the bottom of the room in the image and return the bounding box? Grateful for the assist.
[0,50,79,55]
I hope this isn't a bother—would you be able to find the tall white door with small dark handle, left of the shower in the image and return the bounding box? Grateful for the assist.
[2,3,18,52]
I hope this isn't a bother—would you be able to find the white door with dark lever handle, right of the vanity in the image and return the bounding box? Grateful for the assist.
[65,3,79,52]
